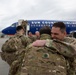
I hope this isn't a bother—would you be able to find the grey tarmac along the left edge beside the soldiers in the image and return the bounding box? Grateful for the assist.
[0,38,10,75]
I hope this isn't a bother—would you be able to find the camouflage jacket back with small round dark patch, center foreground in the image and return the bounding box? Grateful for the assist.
[16,47,67,75]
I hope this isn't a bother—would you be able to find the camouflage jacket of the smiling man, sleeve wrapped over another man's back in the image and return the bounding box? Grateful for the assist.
[46,37,76,75]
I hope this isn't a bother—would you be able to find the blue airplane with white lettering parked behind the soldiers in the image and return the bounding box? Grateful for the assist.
[2,20,76,35]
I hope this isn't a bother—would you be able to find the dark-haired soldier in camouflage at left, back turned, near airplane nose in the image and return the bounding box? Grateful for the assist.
[1,26,31,65]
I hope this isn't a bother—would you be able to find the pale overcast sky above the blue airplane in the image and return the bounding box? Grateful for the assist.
[0,0,76,31]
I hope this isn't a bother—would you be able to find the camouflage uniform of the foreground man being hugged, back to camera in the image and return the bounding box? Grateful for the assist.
[9,34,73,75]
